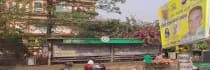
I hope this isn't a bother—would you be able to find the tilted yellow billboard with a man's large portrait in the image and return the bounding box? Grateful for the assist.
[158,0,209,48]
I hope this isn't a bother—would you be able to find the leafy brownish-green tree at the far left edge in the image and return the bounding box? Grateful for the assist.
[0,0,25,54]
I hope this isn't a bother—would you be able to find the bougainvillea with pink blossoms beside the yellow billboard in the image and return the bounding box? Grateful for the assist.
[123,20,161,47]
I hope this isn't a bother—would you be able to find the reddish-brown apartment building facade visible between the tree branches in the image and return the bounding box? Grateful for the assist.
[3,0,96,35]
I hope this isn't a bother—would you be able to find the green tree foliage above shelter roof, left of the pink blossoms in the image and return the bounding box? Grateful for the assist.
[76,19,134,38]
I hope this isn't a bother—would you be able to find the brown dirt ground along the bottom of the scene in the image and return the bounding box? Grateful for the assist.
[0,61,178,70]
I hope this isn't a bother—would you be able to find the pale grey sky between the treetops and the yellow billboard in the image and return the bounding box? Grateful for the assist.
[97,0,170,22]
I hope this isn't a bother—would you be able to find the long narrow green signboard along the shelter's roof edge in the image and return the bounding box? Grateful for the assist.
[63,39,142,44]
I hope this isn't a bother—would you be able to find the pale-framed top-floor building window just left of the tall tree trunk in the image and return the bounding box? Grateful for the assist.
[33,0,43,12]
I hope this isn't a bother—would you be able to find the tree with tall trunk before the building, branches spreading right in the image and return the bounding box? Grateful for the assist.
[47,0,126,37]
